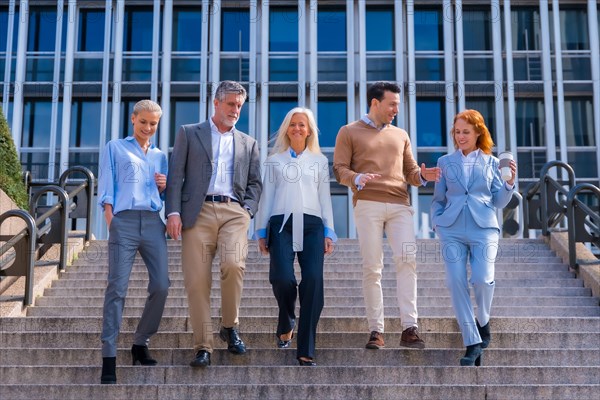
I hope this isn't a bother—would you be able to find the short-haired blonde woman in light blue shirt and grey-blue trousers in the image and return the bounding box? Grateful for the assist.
[98,100,169,384]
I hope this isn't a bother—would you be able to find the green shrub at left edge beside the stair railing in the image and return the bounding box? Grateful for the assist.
[0,109,28,210]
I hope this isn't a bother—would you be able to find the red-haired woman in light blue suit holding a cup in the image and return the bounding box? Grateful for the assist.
[431,110,517,365]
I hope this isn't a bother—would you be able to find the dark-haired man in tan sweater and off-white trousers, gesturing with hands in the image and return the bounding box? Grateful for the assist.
[333,82,440,349]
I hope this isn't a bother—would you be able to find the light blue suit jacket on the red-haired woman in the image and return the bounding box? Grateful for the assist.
[431,150,514,229]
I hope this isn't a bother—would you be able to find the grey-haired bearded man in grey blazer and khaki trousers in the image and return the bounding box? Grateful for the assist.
[166,81,262,367]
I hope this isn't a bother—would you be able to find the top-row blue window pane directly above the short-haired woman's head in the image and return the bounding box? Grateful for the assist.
[123,7,153,51]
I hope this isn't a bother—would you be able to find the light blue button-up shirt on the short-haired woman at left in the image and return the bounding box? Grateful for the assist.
[98,136,167,214]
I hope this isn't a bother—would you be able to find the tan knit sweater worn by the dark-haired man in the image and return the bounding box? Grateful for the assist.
[333,120,421,206]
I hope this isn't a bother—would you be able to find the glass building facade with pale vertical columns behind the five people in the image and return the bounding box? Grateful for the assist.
[0,0,600,237]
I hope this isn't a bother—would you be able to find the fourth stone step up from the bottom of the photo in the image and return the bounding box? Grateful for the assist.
[0,330,600,348]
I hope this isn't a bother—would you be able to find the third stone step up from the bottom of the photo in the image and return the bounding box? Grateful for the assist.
[2,348,600,367]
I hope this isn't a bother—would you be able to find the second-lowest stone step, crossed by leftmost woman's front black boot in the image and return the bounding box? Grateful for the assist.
[0,365,600,386]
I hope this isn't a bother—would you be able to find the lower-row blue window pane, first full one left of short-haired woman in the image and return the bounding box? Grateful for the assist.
[69,101,100,147]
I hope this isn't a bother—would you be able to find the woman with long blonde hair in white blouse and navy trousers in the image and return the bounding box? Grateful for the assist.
[256,107,337,366]
